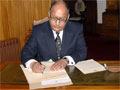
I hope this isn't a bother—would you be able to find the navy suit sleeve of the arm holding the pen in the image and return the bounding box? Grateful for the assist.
[21,27,38,67]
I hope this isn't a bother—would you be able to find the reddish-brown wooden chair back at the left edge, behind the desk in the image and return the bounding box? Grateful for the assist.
[0,38,20,63]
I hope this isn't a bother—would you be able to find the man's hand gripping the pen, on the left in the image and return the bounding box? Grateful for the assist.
[30,62,45,73]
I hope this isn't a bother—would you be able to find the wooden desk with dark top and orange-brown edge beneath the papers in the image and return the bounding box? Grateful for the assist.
[0,61,120,90]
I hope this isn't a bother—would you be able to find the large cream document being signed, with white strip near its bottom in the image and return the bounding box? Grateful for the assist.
[20,61,72,89]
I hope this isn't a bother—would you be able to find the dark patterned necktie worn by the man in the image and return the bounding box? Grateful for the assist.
[56,32,61,60]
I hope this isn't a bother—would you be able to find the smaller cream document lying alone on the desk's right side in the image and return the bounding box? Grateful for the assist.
[75,59,106,74]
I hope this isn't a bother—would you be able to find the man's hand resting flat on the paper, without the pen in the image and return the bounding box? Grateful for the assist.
[50,59,67,71]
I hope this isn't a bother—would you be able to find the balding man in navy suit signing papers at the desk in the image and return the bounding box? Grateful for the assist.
[21,1,87,73]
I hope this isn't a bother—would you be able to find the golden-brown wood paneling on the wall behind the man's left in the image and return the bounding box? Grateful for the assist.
[0,0,54,48]
